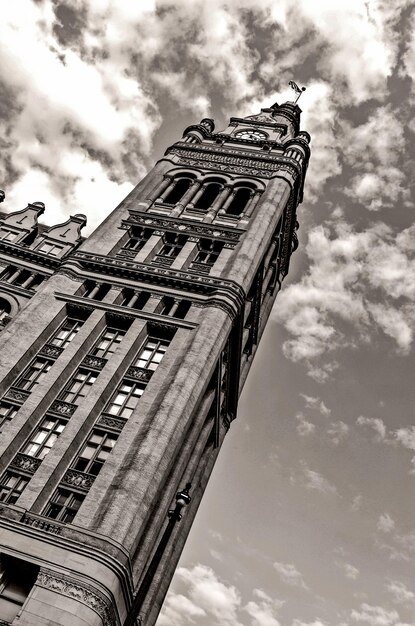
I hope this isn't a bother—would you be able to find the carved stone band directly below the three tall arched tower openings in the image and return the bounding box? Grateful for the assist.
[122,209,245,243]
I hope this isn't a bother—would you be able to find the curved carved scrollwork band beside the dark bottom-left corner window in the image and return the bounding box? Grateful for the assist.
[35,568,120,626]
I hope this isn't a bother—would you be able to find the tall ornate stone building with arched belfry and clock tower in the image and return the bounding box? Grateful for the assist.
[0,102,309,626]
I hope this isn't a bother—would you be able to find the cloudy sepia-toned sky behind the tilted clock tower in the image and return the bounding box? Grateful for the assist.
[0,0,415,626]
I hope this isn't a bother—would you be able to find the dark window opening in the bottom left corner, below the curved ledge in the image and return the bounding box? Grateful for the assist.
[0,554,39,624]
